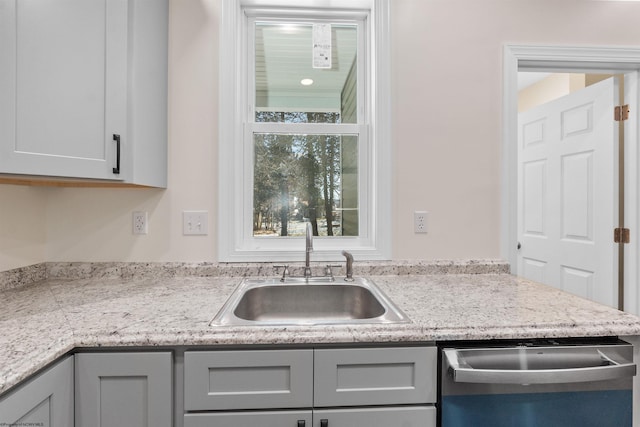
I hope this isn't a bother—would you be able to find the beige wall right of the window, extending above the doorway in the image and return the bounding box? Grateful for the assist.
[392,0,640,258]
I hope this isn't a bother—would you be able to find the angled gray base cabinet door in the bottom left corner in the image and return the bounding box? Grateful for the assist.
[0,356,73,427]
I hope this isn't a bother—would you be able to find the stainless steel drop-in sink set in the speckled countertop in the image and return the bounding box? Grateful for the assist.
[212,278,408,325]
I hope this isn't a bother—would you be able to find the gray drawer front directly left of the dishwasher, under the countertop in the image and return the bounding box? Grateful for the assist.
[314,347,437,407]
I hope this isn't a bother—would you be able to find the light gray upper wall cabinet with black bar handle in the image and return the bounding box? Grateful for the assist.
[0,0,168,187]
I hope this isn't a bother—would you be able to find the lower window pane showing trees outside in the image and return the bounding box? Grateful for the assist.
[253,133,358,236]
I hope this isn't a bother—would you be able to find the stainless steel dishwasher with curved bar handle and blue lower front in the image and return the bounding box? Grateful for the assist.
[438,339,636,427]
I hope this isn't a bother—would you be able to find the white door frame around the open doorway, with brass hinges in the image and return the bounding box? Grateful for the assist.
[500,44,640,314]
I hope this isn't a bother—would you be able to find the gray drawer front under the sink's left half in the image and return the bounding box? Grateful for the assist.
[184,350,313,411]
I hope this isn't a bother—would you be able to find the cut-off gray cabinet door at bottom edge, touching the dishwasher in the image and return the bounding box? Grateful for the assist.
[314,406,436,427]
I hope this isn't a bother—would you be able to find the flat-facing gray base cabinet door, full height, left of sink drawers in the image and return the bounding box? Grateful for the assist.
[75,352,173,427]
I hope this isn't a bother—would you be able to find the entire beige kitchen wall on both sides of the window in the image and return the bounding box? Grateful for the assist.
[0,0,640,270]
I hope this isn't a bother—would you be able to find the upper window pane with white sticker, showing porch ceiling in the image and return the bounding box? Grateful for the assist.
[255,22,358,123]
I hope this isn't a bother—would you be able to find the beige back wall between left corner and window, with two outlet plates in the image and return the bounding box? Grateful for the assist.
[47,0,220,262]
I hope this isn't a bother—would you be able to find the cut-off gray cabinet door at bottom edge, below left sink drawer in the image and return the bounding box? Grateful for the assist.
[184,411,312,427]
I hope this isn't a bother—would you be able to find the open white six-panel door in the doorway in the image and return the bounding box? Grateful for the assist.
[518,78,619,307]
